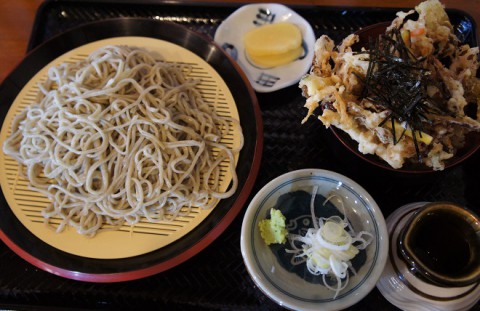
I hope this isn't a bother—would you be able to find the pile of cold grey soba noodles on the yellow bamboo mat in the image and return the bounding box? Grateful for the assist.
[4,46,243,236]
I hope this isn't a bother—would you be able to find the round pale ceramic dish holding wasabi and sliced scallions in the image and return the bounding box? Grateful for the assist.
[240,169,388,310]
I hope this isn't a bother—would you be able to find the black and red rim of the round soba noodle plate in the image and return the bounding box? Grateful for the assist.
[0,17,263,283]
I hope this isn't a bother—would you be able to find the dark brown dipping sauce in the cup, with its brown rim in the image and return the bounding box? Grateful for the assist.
[399,203,480,286]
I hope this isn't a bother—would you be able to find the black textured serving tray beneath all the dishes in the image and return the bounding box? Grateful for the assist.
[0,0,480,310]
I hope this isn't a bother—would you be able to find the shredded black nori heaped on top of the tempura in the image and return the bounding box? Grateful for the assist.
[356,28,445,162]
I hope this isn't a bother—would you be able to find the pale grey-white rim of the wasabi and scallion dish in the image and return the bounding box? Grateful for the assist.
[240,168,389,310]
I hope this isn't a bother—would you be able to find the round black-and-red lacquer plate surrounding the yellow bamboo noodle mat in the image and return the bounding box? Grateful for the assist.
[0,18,263,282]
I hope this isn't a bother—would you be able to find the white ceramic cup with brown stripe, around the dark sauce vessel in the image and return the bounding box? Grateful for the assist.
[377,202,480,311]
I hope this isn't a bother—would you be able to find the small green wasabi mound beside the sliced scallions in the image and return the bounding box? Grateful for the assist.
[258,208,288,245]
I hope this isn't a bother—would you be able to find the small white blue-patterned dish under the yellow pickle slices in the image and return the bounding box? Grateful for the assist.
[214,3,315,93]
